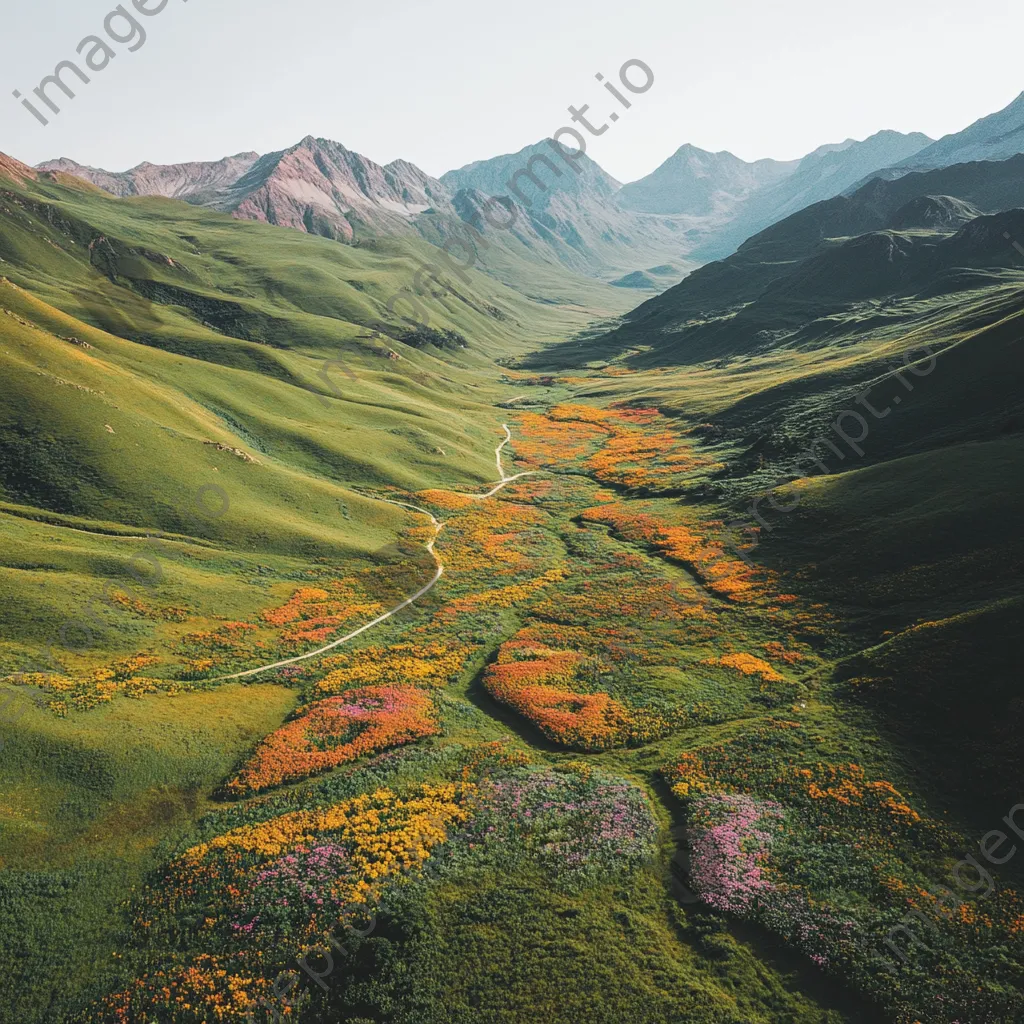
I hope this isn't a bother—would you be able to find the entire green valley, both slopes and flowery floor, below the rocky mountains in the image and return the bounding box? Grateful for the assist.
[0,140,1024,1024]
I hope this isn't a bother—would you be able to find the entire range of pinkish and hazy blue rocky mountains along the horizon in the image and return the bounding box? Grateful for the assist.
[29,94,1024,289]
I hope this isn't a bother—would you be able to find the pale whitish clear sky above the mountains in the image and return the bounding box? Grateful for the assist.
[0,0,1024,181]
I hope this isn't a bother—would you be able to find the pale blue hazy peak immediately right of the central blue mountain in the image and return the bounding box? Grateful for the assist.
[616,144,800,216]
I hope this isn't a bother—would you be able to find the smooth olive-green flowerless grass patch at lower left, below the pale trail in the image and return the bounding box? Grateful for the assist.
[0,685,294,1022]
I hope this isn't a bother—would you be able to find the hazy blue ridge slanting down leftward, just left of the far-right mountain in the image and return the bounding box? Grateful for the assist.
[696,131,932,259]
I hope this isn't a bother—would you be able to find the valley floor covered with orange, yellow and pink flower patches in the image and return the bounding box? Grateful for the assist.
[0,374,1024,1024]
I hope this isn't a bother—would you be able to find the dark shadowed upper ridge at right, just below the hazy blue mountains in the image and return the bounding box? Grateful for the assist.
[606,150,1024,357]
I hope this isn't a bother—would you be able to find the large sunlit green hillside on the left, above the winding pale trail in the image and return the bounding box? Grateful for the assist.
[0,167,624,669]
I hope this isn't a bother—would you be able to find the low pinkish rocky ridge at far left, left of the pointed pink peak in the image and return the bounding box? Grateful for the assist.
[38,153,259,203]
